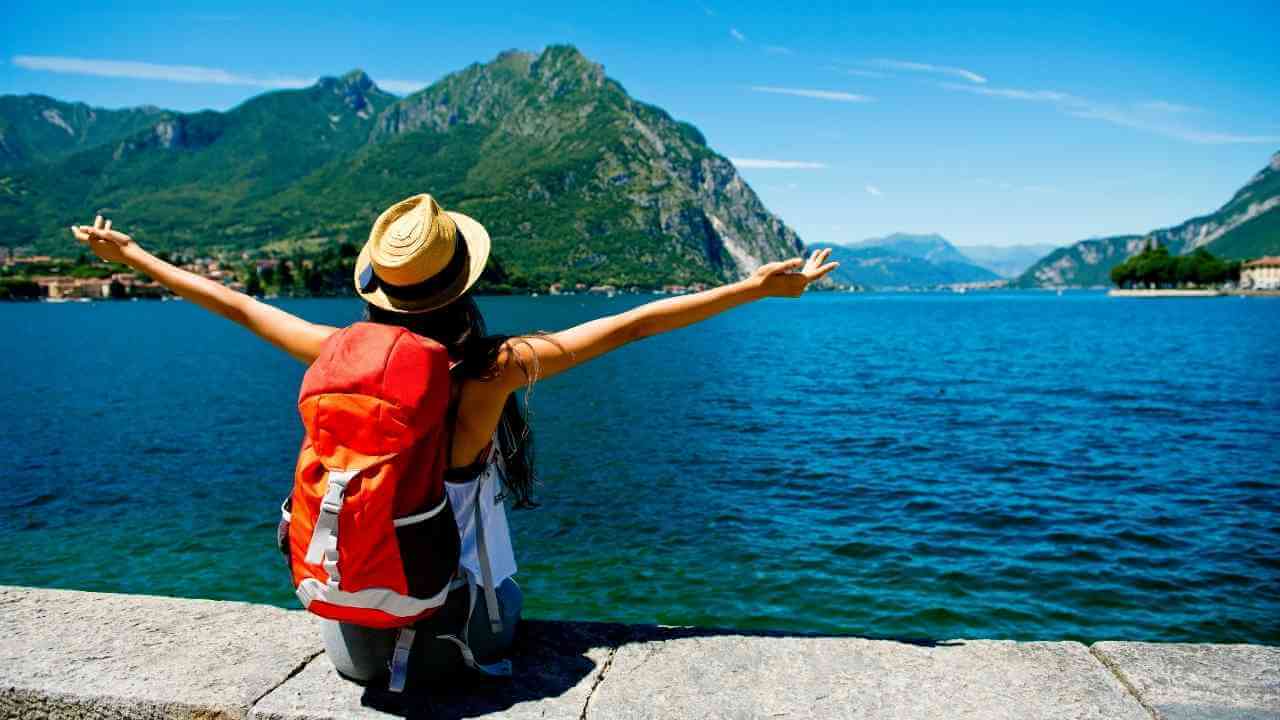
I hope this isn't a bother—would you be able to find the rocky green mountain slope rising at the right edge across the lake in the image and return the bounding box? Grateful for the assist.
[1014,152,1280,287]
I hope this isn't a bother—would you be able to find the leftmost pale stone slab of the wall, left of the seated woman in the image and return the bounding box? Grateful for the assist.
[0,587,321,719]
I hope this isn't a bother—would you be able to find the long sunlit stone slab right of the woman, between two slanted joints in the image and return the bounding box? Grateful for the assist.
[588,630,1149,720]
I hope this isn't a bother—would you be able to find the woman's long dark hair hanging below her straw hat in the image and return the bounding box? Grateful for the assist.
[365,293,538,507]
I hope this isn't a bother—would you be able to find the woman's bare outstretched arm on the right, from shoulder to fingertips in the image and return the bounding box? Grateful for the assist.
[494,250,838,396]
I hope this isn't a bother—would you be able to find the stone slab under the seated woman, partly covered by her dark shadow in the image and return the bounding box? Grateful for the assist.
[252,620,630,720]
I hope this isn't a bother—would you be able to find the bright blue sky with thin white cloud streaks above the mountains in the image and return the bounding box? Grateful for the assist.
[0,0,1280,245]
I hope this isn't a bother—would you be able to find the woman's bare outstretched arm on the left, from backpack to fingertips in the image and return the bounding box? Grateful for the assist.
[72,215,337,365]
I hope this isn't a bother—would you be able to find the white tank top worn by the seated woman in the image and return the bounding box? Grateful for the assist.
[444,437,516,587]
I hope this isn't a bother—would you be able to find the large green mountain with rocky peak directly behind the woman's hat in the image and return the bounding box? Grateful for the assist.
[0,46,803,287]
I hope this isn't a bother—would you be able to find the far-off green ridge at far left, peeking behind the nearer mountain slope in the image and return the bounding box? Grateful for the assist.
[0,95,163,172]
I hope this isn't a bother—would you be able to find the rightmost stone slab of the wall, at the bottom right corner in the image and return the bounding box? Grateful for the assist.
[1092,642,1280,720]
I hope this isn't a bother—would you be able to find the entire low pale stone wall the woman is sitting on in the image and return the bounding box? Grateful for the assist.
[0,585,1280,720]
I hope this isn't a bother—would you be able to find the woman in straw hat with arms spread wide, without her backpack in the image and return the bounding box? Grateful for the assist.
[70,195,837,682]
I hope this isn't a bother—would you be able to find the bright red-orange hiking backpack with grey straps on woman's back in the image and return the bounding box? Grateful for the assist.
[280,323,460,627]
